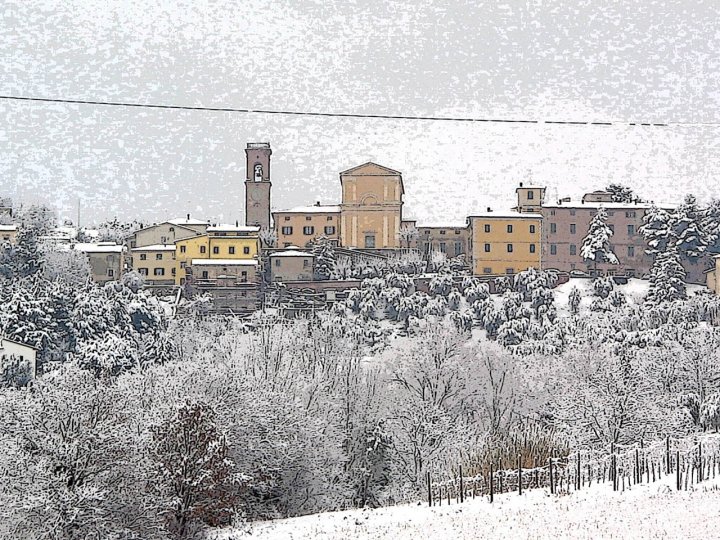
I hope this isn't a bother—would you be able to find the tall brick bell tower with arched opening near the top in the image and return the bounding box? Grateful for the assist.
[245,143,272,228]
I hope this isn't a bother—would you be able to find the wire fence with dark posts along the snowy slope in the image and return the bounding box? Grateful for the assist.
[426,435,720,506]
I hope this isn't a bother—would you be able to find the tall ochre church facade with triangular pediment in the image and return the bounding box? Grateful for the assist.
[338,163,405,249]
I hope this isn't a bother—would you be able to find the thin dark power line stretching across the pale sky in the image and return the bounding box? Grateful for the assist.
[0,95,719,127]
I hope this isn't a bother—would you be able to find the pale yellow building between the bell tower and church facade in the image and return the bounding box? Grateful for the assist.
[273,203,340,248]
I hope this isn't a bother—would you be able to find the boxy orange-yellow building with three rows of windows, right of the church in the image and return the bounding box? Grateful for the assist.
[468,212,542,275]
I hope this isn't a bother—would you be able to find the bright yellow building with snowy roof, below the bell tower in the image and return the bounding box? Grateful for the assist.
[174,225,260,285]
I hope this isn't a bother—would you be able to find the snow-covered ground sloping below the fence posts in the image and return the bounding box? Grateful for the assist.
[213,475,720,540]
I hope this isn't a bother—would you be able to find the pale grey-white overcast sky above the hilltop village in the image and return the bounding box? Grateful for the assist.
[0,0,720,223]
